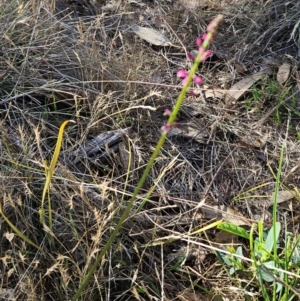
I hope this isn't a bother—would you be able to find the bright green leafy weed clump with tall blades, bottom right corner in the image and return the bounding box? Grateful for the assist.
[217,147,300,301]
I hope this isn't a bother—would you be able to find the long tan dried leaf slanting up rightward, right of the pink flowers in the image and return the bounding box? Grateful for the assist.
[225,68,272,103]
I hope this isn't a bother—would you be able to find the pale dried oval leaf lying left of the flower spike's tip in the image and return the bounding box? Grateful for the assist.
[132,25,172,46]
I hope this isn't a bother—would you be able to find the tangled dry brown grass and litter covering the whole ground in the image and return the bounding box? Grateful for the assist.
[0,0,300,301]
